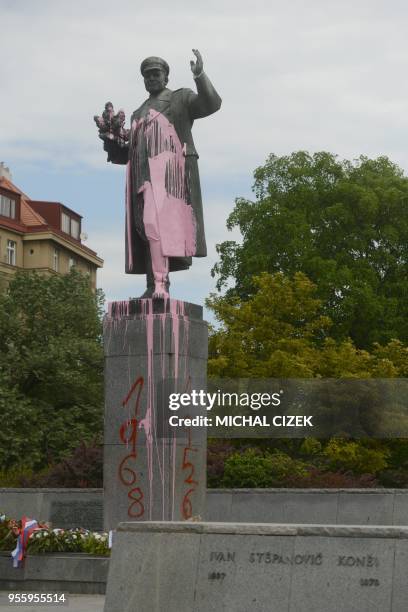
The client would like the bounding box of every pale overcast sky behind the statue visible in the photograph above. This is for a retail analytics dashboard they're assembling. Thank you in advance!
[0,0,408,316]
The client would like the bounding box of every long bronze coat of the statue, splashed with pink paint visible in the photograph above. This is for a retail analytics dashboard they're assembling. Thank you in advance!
[109,73,221,274]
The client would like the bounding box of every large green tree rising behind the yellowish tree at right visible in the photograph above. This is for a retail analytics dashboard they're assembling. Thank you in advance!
[212,151,408,348]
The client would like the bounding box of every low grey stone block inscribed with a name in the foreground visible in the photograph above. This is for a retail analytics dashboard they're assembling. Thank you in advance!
[104,522,408,612]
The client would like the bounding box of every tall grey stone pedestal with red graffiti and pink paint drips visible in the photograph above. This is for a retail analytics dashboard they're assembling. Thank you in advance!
[104,299,208,530]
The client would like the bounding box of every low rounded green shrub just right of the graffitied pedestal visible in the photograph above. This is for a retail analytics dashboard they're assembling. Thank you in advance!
[221,448,307,488]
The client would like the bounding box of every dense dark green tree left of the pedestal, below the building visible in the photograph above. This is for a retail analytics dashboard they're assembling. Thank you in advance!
[0,270,103,469]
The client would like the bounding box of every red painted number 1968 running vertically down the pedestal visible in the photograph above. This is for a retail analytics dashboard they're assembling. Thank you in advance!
[118,376,145,518]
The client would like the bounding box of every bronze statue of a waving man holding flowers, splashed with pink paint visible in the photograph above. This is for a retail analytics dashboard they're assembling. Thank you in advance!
[95,49,221,297]
